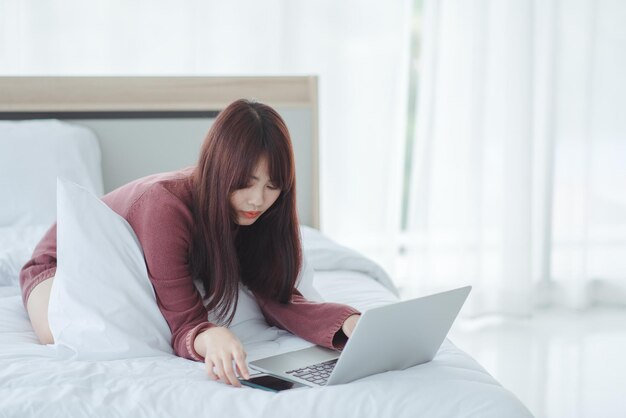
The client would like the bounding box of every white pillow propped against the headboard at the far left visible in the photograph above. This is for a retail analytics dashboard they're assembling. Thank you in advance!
[0,120,103,226]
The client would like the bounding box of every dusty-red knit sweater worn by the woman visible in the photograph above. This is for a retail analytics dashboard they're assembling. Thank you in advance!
[20,169,359,361]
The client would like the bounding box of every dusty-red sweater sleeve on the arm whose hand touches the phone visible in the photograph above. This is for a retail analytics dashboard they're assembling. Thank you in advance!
[128,185,215,361]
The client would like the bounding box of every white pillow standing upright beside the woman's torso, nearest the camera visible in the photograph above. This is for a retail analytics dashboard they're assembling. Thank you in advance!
[48,179,173,360]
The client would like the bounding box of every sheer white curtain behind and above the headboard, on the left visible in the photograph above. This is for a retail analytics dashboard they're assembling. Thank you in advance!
[0,0,410,274]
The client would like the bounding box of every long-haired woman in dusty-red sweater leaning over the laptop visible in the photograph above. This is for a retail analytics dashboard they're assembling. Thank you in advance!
[20,100,360,387]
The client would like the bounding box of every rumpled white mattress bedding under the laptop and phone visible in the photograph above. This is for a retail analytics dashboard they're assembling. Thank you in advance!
[0,270,531,418]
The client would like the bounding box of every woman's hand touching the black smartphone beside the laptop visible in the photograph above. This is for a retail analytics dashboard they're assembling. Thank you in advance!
[194,327,250,387]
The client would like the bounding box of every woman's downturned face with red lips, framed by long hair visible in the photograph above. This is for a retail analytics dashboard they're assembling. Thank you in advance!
[230,157,280,225]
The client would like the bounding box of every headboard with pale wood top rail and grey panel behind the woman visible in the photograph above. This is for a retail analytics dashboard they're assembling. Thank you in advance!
[0,76,319,228]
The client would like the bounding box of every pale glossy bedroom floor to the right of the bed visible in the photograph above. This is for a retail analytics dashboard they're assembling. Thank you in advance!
[449,309,626,418]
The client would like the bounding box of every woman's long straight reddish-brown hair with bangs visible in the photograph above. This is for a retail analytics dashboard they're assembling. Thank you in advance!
[190,99,302,324]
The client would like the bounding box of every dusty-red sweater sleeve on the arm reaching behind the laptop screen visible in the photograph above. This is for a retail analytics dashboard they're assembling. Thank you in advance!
[256,289,361,350]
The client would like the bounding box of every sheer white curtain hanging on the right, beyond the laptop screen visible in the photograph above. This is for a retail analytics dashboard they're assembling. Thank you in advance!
[407,0,626,315]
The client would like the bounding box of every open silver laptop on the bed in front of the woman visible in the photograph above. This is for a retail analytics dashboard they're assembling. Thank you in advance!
[249,286,471,387]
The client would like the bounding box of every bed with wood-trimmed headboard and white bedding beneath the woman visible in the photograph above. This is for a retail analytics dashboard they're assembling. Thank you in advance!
[0,77,531,417]
